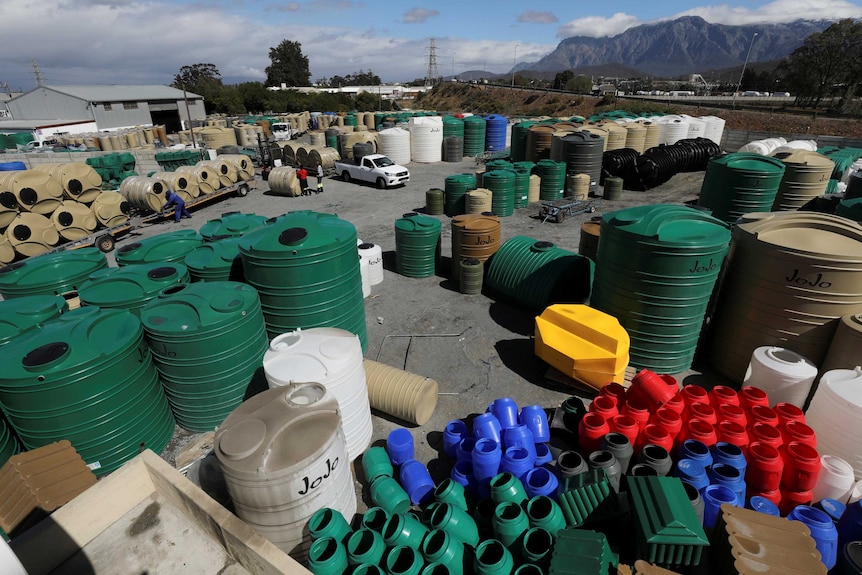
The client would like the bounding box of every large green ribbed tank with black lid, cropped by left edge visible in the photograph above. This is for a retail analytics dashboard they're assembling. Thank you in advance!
[0,306,175,474]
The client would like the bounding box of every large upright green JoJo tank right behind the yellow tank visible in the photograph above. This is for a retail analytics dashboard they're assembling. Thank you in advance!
[590,204,730,374]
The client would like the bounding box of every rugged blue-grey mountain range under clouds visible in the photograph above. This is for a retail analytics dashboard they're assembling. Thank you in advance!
[514,16,833,77]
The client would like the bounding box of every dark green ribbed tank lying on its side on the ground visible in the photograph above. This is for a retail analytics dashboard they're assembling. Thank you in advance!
[484,236,593,313]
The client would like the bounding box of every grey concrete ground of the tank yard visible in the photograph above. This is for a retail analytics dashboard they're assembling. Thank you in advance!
[117,142,736,512]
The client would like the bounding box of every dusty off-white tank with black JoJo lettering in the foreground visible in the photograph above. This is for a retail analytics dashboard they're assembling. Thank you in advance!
[213,383,356,561]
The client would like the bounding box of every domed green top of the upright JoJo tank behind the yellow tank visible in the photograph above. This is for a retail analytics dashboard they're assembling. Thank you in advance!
[602,204,730,247]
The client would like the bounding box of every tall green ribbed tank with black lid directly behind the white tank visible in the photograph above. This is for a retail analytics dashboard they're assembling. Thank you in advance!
[239,210,368,352]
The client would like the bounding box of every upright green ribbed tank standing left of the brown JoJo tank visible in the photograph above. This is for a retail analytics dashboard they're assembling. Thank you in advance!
[395,212,442,278]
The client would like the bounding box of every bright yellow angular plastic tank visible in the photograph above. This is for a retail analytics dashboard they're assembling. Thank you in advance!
[535,304,629,389]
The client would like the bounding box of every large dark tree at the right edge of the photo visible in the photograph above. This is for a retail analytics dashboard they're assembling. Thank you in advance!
[779,18,862,107]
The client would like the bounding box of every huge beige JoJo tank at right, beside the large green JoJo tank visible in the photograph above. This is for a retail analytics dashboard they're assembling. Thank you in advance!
[712,211,862,382]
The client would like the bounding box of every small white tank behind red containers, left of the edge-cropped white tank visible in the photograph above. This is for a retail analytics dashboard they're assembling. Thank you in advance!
[743,345,817,408]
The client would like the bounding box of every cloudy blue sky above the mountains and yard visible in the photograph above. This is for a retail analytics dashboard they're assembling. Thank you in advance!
[0,0,862,91]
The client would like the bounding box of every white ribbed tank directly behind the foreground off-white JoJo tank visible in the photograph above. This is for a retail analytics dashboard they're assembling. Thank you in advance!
[263,327,372,461]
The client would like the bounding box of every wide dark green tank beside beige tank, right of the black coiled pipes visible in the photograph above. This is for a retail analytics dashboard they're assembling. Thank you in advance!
[697,152,784,223]
